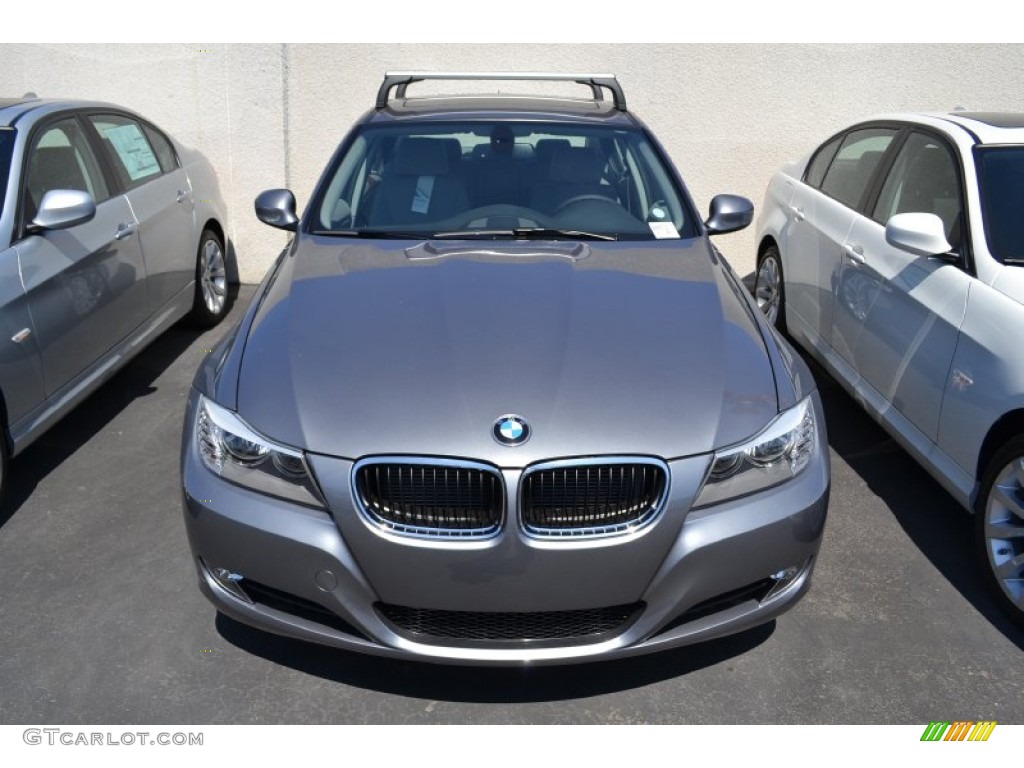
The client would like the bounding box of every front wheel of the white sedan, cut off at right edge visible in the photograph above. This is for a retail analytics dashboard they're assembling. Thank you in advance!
[975,435,1024,628]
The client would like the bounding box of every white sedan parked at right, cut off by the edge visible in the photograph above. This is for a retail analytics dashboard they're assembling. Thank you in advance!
[755,112,1024,625]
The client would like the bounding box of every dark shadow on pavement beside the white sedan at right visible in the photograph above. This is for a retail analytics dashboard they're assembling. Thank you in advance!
[801,350,1024,650]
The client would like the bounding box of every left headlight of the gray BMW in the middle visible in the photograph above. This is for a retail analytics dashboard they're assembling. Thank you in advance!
[196,395,324,507]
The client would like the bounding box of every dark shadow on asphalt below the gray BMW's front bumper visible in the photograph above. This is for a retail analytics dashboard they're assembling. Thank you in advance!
[217,613,775,703]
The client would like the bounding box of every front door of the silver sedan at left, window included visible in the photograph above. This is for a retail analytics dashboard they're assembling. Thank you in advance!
[14,117,146,396]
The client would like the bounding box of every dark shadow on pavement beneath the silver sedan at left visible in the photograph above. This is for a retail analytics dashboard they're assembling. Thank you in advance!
[0,315,222,527]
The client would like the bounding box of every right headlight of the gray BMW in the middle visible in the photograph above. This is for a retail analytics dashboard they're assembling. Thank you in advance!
[693,397,816,509]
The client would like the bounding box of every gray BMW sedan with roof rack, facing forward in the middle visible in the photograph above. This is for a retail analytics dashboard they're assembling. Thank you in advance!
[181,73,829,665]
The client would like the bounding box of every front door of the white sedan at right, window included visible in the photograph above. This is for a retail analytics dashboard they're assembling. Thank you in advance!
[836,131,972,440]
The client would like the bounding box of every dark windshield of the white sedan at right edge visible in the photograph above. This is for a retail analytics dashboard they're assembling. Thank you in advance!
[977,146,1024,262]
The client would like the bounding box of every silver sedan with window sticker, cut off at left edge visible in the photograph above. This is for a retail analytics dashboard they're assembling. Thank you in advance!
[0,97,227,501]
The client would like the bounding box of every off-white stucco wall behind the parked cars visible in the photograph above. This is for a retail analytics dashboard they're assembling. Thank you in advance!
[0,43,1024,282]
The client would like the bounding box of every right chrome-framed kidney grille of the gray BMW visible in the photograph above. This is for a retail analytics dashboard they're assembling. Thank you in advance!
[519,456,670,540]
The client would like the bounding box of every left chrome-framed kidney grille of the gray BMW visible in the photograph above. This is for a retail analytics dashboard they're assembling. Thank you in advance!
[352,456,505,541]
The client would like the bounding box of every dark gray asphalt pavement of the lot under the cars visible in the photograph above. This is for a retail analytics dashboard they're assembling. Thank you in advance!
[0,287,1024,726]
